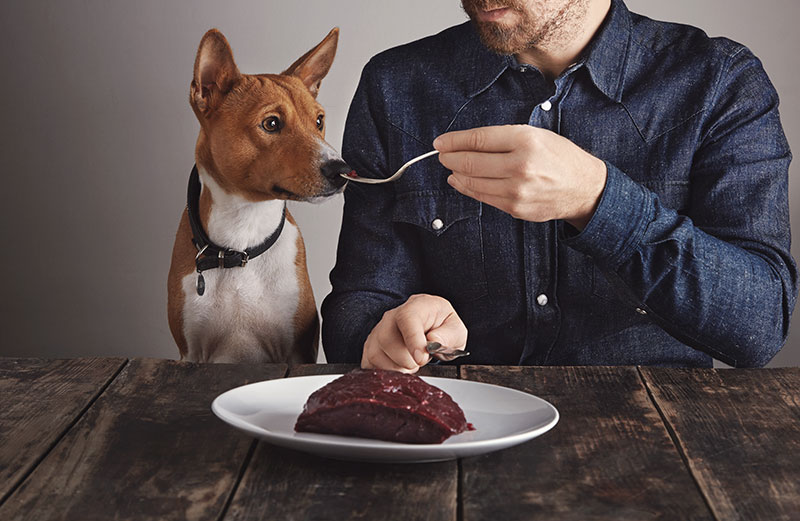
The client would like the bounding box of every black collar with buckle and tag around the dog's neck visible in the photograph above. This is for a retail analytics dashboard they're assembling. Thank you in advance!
[186,165,286,274]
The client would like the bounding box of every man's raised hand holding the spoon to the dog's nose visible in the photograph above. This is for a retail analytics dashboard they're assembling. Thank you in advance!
[433,125,607,230]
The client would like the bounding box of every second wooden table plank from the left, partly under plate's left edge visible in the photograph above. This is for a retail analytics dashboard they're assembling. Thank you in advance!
[0,359,286,520]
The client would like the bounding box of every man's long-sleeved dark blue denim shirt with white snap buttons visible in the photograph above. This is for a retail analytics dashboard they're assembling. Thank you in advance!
[322,0,797,367]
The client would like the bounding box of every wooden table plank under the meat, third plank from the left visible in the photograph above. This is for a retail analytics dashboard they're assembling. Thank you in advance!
[225,365,458,521]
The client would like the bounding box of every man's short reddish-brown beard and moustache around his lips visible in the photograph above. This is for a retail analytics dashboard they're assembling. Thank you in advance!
[461,0,586,55]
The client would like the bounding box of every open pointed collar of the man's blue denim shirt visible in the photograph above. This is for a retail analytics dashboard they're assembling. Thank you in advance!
[464,0,631,102]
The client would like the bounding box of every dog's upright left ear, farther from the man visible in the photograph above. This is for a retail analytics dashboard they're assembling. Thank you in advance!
[189,29,242,114]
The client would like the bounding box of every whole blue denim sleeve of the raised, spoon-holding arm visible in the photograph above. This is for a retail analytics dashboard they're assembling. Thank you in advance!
[561,48,797,367]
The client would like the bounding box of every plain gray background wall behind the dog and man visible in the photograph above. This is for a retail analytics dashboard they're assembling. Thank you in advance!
[0,0,800,366]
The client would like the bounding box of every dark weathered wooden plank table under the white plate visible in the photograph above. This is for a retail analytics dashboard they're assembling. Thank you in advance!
[0,358,800,521]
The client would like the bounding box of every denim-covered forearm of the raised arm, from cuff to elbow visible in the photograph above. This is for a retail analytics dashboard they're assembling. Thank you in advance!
[566,167,796,366]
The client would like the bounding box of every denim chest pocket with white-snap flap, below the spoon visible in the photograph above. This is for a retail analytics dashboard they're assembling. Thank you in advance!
[393,191,488,302]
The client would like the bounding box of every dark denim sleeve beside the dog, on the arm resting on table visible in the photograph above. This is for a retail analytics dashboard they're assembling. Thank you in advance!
[321,64,422,363]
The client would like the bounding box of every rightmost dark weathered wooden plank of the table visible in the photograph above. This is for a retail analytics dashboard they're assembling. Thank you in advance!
[641,367,800,521]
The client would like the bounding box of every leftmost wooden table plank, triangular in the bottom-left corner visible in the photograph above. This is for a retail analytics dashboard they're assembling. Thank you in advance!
[0,358,126,504]
